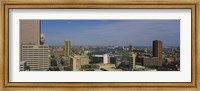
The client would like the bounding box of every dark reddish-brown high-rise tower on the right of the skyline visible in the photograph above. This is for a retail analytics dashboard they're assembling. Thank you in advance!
[153,40,162,65]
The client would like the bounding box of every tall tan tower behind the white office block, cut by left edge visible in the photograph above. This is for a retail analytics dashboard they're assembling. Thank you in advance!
[20,20,40,61]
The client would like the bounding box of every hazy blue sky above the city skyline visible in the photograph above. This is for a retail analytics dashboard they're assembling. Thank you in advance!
[41,20,180,46]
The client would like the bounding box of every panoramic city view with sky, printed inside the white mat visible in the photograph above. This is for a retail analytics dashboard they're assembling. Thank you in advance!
[19,20,180,71]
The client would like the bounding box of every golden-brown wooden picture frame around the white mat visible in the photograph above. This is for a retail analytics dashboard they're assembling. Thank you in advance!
[0,1,200,91]
